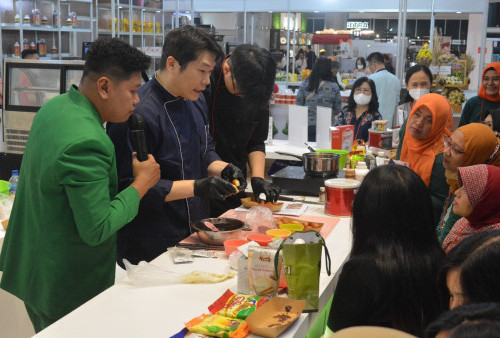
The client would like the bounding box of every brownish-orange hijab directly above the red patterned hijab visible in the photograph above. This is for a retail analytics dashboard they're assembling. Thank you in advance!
[446,123,500,193]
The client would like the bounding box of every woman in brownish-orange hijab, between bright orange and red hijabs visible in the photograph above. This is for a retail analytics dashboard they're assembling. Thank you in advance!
[437,123,500,242]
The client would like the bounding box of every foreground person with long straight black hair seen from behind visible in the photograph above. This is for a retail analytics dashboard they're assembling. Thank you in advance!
[327,164,446,336]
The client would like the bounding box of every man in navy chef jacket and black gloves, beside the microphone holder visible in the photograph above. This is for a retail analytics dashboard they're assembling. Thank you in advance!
[108,25,246,266]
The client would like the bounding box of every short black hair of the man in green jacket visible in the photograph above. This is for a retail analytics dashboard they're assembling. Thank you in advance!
[82,38,151,82]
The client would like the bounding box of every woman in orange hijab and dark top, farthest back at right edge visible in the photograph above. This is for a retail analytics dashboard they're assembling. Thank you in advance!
[458,62,500,126]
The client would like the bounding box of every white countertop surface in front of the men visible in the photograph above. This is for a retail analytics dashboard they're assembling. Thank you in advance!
[36,205,352,338]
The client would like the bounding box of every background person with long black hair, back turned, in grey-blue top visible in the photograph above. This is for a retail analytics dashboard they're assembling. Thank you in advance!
[297,58,341,141]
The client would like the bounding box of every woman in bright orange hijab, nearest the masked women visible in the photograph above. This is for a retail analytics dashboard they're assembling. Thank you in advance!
[400,93,452,223]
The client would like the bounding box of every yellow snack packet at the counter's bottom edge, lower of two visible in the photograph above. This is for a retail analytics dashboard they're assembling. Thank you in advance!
[185,314,250,338]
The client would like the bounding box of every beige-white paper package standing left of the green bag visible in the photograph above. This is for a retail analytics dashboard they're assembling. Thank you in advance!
[248,246,281,297]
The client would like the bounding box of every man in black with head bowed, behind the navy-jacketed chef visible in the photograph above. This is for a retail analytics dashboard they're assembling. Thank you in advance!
[206,44,280,217]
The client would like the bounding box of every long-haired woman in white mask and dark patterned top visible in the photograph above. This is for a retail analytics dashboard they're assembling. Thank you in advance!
[333,77,382,141]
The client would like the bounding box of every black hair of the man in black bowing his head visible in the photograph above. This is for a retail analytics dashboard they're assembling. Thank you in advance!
[228,44,276,107]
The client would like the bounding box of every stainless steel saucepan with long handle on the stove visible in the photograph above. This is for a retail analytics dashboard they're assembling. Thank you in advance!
[276,151,340,177]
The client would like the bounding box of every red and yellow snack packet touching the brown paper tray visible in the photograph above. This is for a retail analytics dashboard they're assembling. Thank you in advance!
[208,290,267,319]
